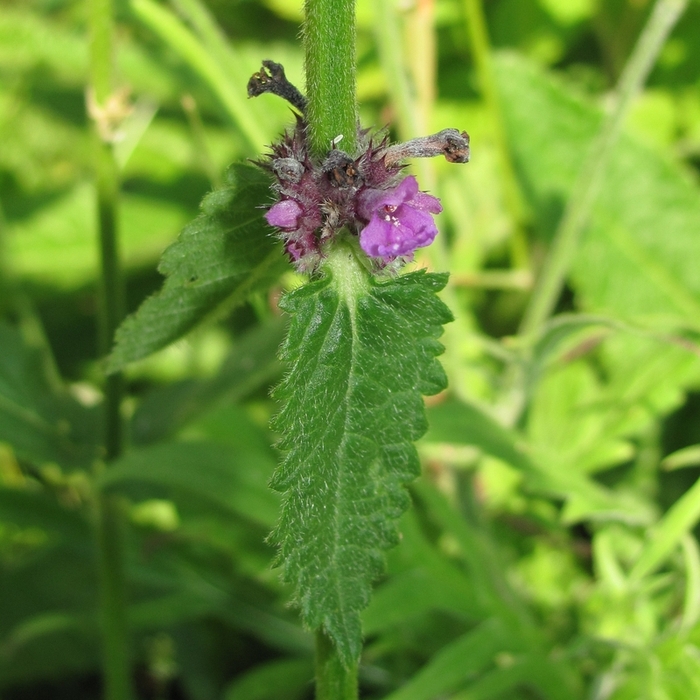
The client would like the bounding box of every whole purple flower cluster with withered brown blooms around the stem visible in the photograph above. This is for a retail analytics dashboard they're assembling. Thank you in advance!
[248,61,469,272]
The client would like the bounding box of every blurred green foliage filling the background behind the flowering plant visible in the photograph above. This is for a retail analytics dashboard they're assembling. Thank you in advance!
[0,0,700,700]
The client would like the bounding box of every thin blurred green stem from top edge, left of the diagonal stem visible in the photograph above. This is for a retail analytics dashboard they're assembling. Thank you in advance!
[464,0,528,268]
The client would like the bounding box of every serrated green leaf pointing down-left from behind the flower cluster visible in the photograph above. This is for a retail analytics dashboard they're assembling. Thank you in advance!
[108,164,286,372]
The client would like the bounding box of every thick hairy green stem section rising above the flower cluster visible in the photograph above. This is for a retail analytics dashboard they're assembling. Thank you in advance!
[304,0,357,158]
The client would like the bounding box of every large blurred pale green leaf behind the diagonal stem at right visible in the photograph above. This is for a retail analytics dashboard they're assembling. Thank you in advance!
[497,54,700,328]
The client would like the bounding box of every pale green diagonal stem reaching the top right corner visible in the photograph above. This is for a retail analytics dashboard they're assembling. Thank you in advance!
[521,0,688,334]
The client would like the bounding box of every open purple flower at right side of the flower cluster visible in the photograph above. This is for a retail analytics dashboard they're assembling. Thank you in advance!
[357,175,442,262]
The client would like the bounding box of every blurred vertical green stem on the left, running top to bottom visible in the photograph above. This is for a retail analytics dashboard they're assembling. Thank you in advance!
[88,0,132,700]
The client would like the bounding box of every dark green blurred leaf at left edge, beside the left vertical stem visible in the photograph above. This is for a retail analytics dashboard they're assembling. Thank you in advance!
[0,324,99,468]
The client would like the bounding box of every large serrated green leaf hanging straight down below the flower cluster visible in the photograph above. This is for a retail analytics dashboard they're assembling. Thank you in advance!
[272,243,452,665]
